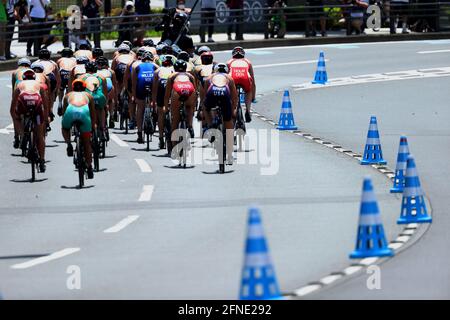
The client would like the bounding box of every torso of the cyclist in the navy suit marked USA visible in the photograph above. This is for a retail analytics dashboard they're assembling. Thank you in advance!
[204,73,231,121]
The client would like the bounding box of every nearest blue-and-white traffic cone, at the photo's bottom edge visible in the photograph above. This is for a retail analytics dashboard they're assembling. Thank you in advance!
[239,207,281,300]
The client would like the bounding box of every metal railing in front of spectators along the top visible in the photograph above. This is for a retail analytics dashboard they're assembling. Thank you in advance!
[0,2,450,41]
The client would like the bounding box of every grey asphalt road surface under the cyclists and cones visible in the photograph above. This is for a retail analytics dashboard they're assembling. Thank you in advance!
[0,41,450,299]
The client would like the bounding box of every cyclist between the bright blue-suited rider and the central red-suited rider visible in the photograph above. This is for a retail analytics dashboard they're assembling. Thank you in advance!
[152,57,175,149]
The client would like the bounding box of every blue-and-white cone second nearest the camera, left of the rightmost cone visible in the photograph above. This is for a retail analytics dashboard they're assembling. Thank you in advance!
[350,177,394,259]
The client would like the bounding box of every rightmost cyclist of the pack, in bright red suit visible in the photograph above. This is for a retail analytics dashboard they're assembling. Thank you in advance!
[227,47,256,122]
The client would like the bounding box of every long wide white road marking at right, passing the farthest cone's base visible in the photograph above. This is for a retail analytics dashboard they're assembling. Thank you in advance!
[292,67,450,91]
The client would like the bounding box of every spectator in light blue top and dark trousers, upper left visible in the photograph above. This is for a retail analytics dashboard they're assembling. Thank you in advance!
[27,0,50,57]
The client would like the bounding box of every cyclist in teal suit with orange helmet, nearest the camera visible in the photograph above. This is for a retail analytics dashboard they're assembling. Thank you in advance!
[61,79,97,179]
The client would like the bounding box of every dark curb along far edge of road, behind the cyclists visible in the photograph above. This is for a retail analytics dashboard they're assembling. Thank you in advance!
[0,32,450,72]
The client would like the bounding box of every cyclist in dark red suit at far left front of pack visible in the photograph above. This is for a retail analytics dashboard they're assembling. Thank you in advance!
[10,69,47,172]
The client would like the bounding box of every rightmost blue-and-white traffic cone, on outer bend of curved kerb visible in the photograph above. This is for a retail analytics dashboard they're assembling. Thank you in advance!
[397,155,432,224]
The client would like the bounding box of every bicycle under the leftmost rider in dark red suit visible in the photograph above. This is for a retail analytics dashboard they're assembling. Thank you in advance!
[22,108,40,182]
